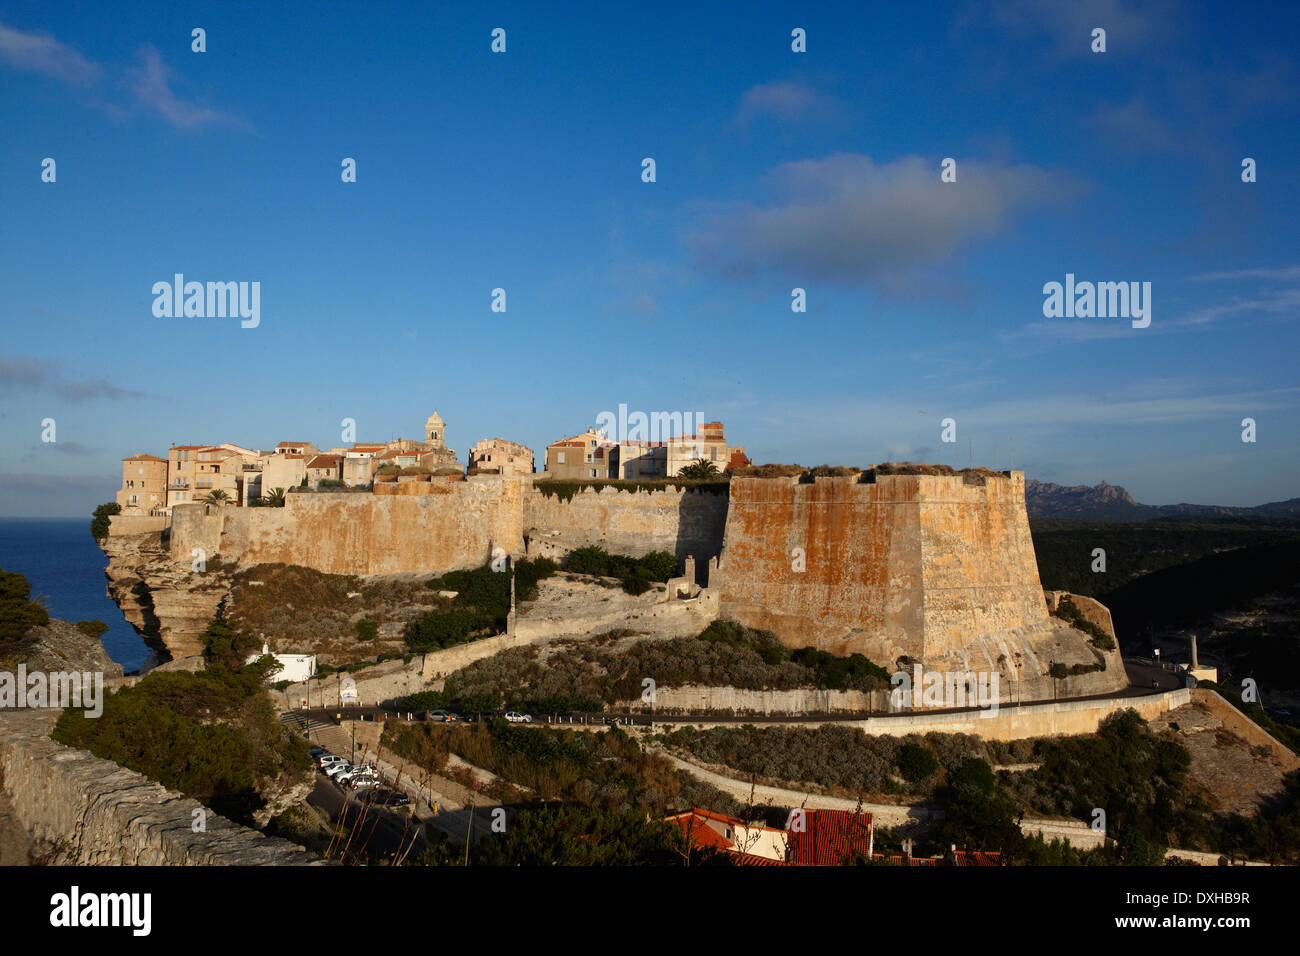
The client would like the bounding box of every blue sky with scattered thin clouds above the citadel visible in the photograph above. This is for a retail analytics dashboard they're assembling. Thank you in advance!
[0,0,1300,515]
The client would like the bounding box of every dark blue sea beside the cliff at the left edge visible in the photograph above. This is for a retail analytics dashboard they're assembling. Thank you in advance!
[0,518,150,672]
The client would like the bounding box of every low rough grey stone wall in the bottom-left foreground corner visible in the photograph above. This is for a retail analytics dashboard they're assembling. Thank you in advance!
[0,710,321,866]
